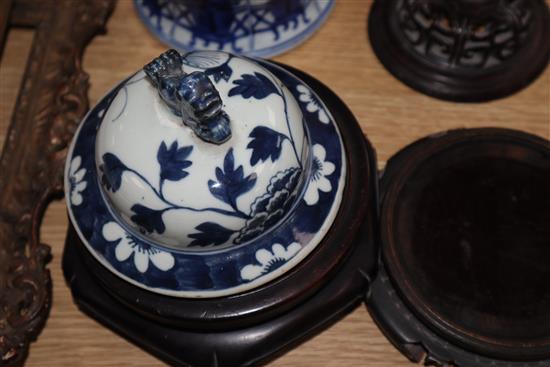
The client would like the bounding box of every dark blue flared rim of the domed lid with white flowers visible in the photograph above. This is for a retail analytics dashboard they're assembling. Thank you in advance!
[66,62,345,297]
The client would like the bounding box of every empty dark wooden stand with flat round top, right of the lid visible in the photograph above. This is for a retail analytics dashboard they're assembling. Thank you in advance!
[367,128,550,367]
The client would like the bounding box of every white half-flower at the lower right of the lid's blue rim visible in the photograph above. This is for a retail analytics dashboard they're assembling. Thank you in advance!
[241,242,302,280]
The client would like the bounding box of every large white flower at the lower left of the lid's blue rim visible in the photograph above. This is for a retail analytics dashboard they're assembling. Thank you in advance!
[102,222,174,273]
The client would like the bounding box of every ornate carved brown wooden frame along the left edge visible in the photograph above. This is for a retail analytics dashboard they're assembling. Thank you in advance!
[0,0,115,365]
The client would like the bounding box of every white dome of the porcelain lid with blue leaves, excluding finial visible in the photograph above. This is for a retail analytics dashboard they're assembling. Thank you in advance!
[95,52,314,250]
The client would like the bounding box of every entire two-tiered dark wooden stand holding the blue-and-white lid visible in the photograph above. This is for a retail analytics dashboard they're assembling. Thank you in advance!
[63,67,378,366]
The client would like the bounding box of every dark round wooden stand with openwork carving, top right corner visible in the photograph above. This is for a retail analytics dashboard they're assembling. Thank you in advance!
[368,0,550,102]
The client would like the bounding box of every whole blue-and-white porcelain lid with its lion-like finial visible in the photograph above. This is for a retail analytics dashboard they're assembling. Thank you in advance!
[65,51,345,297]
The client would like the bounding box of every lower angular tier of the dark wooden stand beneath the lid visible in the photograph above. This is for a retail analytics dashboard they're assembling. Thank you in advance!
[63,218,376,366]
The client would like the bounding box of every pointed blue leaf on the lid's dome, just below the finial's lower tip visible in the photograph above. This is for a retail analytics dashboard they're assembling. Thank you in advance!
[208,148,256,211]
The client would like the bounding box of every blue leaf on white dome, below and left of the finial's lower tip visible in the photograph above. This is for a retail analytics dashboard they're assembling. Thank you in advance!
[157,141,193,181]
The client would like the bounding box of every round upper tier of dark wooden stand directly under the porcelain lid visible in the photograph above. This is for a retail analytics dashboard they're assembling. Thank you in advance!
[63,61,376,329]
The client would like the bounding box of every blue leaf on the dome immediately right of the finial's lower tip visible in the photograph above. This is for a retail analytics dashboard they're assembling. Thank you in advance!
[246,126,288,166]
